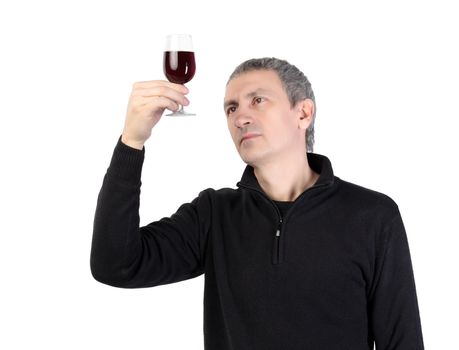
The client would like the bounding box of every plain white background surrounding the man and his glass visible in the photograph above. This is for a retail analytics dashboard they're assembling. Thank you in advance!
[0,0,459,350]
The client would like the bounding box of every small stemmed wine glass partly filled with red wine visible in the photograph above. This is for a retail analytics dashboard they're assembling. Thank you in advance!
[163,34,196,116]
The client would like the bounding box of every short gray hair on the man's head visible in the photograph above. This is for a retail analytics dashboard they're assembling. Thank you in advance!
[227,57,316,152]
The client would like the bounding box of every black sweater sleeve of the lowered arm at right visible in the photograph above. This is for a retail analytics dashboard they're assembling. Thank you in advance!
[368,210,424,350]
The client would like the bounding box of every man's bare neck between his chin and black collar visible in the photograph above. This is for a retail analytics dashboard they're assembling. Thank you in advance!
[254,154,319,202]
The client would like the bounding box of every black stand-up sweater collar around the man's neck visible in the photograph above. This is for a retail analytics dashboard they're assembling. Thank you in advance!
[237,152,334,191]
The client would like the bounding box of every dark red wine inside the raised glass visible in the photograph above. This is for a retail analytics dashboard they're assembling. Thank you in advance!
[164,51,196,84]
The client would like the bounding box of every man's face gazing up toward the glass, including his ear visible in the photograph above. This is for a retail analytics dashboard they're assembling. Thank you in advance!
[224,70,313,166]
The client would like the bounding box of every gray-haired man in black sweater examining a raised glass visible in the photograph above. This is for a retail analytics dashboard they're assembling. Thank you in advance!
[91,58,424,350]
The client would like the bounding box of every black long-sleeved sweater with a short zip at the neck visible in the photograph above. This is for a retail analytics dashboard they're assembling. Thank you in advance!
[91,138,424,350]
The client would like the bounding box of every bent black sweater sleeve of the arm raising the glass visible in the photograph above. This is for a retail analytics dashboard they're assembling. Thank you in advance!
[90,137,208,288]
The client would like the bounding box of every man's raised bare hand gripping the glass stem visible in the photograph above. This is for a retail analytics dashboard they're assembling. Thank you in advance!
[121,80,189,150]
